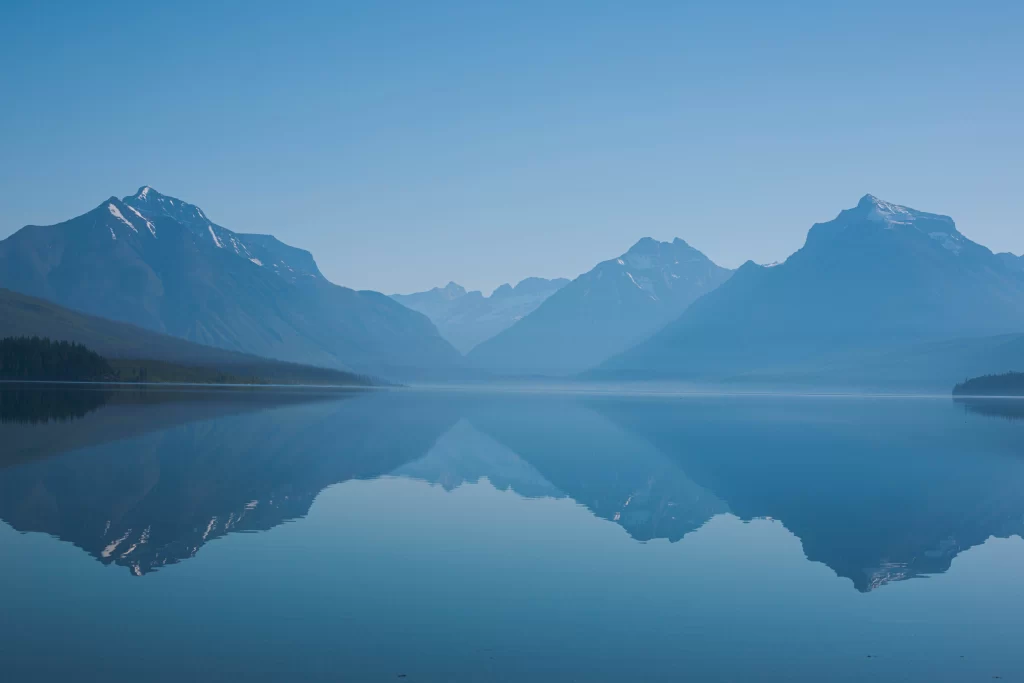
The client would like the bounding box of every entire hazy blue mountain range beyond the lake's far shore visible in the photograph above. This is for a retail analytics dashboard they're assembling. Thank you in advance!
[0,186,1024,388]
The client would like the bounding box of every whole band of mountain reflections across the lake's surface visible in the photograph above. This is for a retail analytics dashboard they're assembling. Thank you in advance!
[0,391,1024,591]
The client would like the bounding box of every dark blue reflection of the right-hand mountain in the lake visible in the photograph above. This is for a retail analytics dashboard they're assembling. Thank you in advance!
[594,397,1024,591]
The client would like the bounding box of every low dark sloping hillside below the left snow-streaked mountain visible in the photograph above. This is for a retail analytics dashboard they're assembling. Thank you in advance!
[0,289,366,384]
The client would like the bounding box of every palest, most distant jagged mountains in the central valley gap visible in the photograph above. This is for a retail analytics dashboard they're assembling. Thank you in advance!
[391,278,569,353]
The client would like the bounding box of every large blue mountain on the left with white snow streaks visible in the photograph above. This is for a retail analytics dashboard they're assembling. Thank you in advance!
[0,187,459,376]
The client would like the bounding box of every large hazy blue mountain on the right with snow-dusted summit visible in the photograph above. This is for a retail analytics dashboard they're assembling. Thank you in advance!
[595,195,1024,379]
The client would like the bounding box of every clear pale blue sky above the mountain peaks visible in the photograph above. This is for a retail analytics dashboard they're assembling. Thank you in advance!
[0,0,1024,293]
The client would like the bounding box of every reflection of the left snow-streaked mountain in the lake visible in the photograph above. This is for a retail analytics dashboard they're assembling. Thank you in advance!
[0,393,457,575]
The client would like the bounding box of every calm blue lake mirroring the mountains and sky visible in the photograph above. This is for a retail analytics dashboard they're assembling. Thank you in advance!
[0,385,1024,683]
